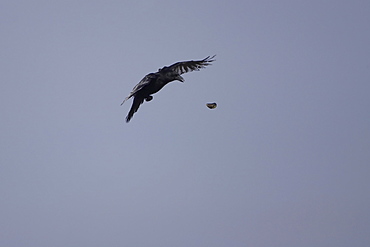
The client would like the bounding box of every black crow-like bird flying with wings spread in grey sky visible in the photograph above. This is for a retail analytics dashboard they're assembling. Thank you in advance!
[121,56,215,123]
